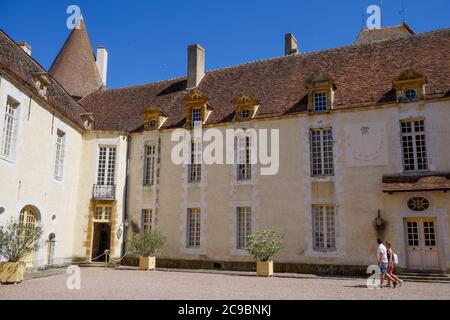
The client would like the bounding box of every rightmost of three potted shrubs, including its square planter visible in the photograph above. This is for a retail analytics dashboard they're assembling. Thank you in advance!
[246,230,283,277]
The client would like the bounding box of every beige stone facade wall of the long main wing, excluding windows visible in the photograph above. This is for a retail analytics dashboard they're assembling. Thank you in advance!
[125,102,450,269]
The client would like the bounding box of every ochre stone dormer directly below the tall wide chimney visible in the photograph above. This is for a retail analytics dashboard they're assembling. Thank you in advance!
[184,89,213,128]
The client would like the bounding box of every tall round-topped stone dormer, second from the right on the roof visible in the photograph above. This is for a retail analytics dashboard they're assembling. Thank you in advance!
[306,72,336,113]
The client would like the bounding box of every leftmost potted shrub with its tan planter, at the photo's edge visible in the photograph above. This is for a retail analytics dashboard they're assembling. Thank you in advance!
[0,221,42,283]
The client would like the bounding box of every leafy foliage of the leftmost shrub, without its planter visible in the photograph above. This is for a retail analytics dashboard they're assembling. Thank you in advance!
[0,221,43,262]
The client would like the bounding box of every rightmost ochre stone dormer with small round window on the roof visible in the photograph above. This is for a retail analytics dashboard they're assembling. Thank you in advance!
[393,69,427,102]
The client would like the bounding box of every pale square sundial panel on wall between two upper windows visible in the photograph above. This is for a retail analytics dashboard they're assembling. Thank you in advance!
[345,122,388,167]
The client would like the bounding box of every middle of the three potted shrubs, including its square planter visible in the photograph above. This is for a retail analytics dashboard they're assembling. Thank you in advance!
[130,231,166,270]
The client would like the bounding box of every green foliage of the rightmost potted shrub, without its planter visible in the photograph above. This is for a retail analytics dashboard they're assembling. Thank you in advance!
[245,230,284,262]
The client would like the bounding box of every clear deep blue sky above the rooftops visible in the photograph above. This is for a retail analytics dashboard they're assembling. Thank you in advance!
[0,0,450,88]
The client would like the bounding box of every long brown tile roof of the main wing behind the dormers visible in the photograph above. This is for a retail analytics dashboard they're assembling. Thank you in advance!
[81,29,450,131]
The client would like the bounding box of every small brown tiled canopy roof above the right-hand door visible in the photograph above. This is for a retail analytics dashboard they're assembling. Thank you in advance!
[383,173,450,193]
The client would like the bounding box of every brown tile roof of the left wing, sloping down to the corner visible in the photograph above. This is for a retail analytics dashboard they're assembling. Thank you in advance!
[0,30,86,128]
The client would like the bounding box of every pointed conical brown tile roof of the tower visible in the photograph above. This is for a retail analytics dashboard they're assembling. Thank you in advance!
[49,18,103,98]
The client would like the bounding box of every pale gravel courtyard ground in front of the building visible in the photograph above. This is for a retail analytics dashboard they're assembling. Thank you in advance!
[0,268,450,300]
